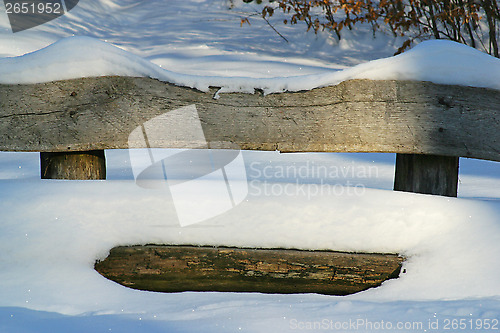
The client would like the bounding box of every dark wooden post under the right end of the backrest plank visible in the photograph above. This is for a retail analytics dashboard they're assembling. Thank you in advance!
[394,154,458,197]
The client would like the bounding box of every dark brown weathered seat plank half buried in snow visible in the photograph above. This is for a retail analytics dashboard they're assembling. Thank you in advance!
[95,245,403,295]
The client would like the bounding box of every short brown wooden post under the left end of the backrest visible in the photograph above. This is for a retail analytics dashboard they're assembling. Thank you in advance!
[40,150,106,180]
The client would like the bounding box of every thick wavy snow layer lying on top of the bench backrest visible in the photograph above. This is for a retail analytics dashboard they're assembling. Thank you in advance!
[0,37,500,93]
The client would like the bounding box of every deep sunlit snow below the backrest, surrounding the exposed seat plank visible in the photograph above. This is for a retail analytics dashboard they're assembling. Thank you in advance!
[0,151,500,332]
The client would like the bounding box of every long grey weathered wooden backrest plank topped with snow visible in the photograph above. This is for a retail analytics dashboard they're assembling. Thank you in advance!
[0,77,500,161]
